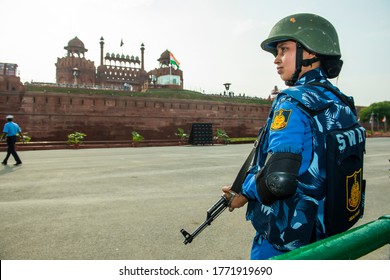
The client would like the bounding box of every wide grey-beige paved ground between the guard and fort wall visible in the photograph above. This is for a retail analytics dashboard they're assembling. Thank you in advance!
[0,138,390,260]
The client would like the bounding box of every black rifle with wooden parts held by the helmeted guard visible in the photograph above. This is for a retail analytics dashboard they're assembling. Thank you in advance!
[180,130,263,245]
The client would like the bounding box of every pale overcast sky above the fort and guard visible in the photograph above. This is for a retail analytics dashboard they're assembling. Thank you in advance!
[0,0,390,106]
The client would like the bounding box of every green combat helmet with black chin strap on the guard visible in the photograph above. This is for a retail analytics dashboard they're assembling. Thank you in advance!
[261,14,342,82]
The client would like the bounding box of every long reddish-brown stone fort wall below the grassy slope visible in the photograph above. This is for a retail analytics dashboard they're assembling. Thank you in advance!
[0,92,270,141]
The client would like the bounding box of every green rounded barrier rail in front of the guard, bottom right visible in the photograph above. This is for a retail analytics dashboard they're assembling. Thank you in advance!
[270,215,390,260]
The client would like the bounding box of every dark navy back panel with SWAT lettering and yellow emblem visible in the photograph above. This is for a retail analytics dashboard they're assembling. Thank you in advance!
[325,124,366,236]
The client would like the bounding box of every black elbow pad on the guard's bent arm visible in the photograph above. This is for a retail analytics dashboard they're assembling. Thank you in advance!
[256,153,302,205]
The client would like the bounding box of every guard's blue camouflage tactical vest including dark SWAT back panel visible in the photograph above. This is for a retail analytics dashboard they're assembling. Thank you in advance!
[282,83,366,236]
